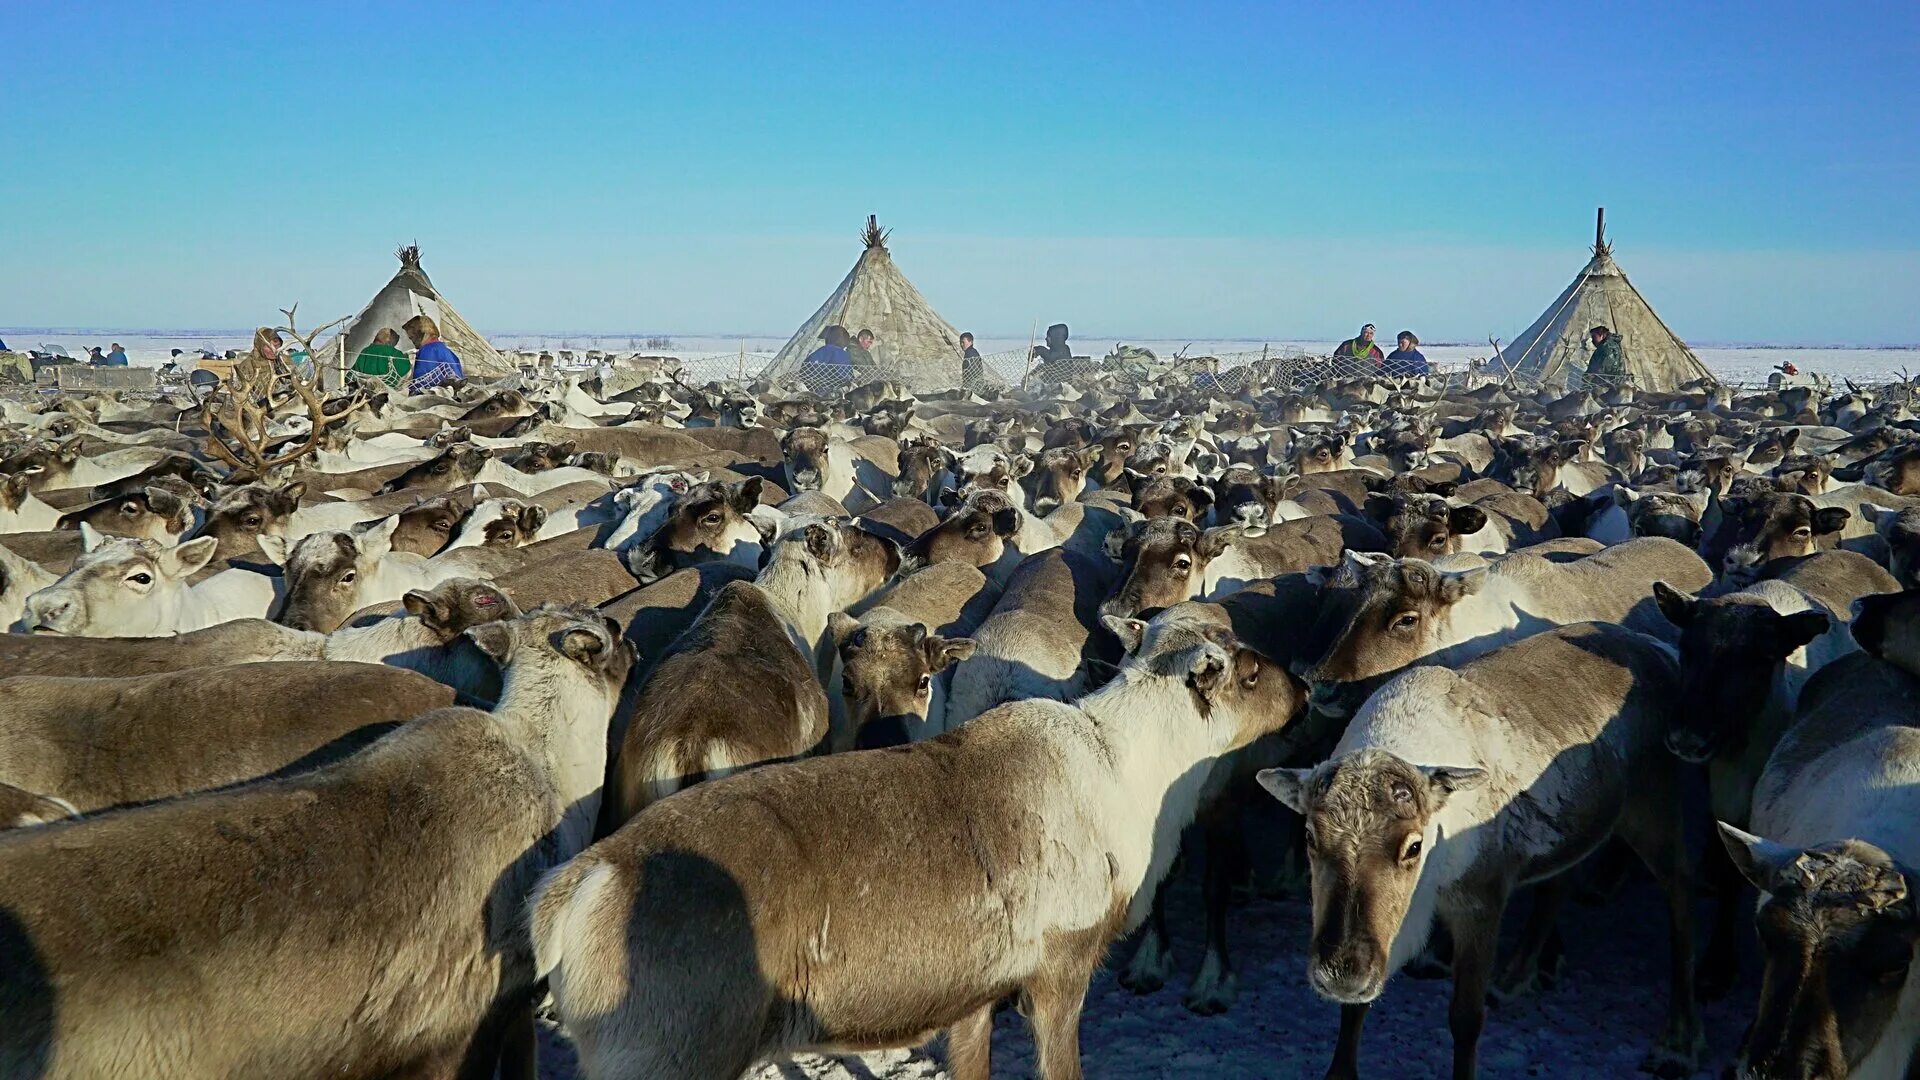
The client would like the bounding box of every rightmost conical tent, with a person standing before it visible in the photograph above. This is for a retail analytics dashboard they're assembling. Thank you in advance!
[1501,209,1715,392]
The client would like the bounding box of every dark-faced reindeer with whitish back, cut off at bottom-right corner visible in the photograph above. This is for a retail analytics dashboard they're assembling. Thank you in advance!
[1720,592,1920,1080]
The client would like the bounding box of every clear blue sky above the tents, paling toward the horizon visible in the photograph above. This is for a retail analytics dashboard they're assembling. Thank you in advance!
[0,0,1920,342]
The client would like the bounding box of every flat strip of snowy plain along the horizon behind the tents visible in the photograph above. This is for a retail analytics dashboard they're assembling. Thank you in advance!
[0,327,1920,384]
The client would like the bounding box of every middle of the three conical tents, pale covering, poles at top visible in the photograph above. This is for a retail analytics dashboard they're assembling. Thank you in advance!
[766,215,960,390]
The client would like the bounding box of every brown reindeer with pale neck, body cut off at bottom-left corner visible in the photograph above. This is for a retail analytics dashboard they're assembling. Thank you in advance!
[0,607,632,1080]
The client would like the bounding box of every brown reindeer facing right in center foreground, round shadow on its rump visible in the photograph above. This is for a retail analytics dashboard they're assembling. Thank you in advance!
[532,605,1288,1080]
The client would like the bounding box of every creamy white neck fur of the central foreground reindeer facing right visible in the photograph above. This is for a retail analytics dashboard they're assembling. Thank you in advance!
[1075,669,1221,930]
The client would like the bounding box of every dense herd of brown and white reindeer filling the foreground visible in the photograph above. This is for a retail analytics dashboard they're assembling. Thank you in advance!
[0,363,1920,1080]
